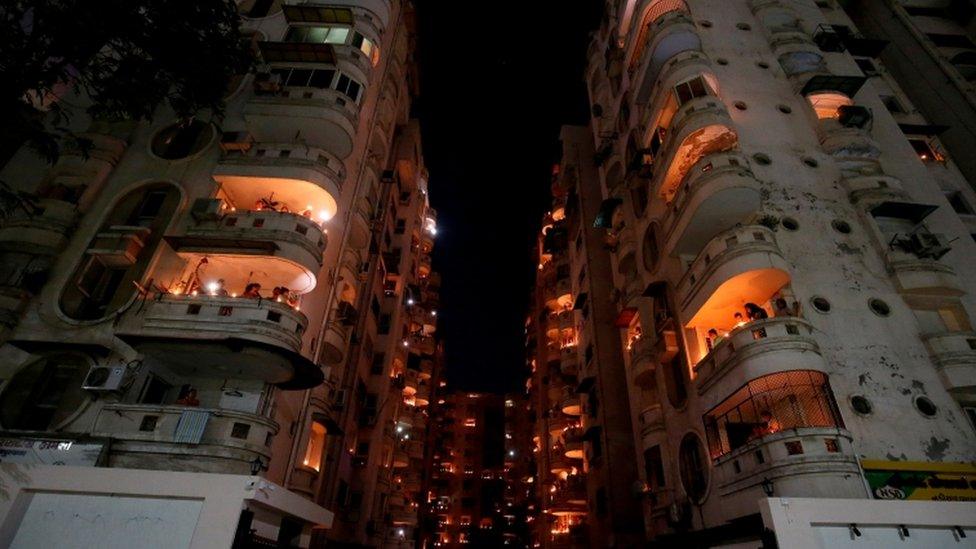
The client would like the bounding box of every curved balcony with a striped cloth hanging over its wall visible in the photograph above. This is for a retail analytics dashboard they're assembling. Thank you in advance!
[91,403,278,475]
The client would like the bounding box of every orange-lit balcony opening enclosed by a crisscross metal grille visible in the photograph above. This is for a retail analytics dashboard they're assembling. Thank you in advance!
[702,370,844,459]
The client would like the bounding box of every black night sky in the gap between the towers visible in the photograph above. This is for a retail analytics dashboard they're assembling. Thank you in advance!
[414,0,603,392]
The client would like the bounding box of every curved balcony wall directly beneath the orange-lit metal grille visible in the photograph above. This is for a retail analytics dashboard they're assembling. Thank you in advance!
[713,427,869,519]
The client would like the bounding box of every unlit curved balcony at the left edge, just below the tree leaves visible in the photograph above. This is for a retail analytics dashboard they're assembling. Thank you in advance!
[0,198,78,255]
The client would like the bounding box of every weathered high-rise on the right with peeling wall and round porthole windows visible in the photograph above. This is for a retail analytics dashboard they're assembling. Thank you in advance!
[527,0,976,547]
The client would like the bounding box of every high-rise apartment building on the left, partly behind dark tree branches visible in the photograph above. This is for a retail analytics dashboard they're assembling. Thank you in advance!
[0,0,441,547]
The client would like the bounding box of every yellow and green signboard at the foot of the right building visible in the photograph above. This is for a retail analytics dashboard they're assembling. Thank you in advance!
[861,460,976,501]
